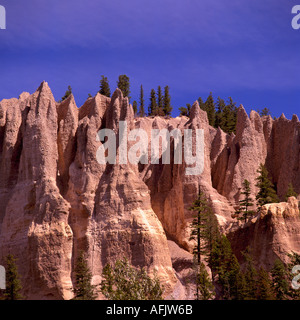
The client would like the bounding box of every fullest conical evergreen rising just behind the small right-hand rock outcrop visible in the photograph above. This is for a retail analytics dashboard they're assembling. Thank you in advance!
[256,164,279,207]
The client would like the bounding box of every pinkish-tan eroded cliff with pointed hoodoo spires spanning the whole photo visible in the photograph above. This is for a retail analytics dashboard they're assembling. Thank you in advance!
[0,82,300,299]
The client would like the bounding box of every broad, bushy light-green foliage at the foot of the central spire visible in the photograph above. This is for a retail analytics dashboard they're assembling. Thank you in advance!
[101,258,163,300]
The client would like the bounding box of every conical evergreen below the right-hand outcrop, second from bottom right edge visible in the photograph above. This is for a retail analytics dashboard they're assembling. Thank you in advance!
[271,259,289,300]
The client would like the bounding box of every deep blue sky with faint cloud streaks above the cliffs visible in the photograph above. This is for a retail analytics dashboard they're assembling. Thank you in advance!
[0,0,300,118]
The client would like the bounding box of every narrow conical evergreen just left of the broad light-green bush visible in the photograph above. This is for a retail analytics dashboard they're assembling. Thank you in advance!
[73,251,96,300]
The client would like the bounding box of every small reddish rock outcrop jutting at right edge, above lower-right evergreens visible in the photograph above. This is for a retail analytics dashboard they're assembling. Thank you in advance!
[229,197,300,270]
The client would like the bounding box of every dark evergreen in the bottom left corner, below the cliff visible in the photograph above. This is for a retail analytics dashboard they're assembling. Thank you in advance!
[4,254,23,300]
